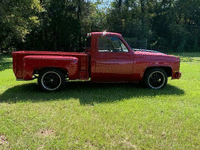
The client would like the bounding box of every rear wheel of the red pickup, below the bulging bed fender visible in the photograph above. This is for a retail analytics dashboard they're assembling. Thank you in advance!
[38,69,65,92]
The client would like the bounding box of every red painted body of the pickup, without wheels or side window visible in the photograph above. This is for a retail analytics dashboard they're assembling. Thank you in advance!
[12,32,181,82]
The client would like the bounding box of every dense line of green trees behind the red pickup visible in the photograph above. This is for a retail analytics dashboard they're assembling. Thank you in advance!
[0,0,200,52]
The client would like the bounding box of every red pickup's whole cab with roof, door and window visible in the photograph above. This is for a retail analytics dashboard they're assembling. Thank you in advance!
[86,32,134,82]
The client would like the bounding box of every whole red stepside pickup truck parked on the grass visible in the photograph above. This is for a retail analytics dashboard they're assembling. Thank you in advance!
[12,32,181,91]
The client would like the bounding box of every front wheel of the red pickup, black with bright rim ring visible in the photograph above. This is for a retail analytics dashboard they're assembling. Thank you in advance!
[144,68,168,90]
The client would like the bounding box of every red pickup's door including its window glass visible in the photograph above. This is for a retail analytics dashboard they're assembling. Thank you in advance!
[93,36,133,82]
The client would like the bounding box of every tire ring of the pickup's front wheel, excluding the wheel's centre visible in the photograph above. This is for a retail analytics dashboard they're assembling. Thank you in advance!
[144,68,168,90]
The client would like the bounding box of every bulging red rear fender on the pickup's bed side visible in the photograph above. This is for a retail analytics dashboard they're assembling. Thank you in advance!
[23,55,79,80]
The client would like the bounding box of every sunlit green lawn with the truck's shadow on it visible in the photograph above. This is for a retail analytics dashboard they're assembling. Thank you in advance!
[0,53,200,150]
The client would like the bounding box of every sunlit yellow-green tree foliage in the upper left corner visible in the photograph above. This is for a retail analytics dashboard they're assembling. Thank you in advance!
[0,0,43,48]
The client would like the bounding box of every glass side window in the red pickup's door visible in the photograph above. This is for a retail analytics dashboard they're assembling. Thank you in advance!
[98,36,128,53]
